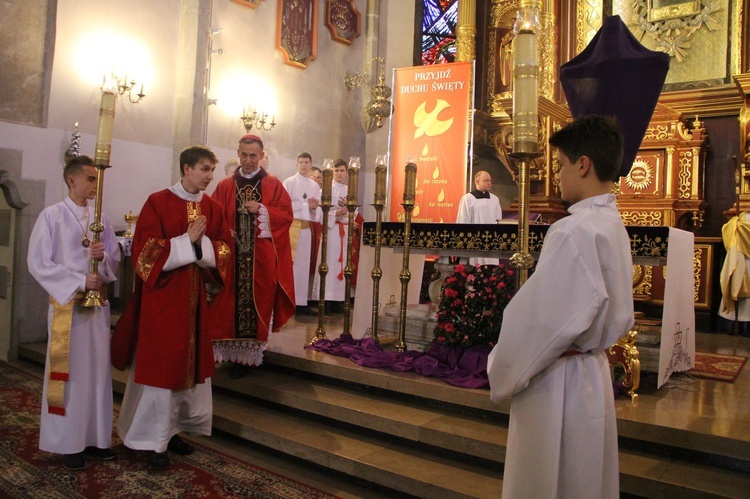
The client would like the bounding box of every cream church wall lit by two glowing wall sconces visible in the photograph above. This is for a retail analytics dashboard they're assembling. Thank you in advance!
[0,0,374,233]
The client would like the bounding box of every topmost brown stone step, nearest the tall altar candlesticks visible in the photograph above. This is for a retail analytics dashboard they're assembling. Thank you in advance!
[265,351,750,471]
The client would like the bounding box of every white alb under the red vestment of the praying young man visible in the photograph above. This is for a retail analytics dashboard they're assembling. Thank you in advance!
[117,182,216,452]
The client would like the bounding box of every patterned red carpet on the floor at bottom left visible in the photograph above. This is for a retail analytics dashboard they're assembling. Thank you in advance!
[0,362,334,499]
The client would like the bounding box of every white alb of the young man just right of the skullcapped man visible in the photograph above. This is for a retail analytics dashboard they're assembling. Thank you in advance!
[283,173,321,307]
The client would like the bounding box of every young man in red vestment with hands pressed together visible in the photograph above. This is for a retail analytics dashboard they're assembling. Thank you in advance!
[112,146,231,468]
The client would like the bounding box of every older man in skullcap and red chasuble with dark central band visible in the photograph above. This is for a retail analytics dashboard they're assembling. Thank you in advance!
[213,135,295,375]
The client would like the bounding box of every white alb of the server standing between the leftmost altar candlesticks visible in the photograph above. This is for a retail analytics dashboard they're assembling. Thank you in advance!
[312,182,357,301]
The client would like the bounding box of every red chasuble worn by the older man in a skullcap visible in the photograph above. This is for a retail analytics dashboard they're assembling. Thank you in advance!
[213,171,295,343]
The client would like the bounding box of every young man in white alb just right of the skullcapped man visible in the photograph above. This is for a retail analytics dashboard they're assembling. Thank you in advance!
[284,152,322,317]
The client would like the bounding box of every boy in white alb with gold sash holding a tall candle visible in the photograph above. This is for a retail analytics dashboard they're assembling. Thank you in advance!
[27,156,120,470]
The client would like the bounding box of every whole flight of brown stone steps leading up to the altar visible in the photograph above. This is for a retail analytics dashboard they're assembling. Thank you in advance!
[20,344,750,497]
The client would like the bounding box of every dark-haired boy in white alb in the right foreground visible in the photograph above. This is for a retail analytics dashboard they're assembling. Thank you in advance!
[487,116,633,499]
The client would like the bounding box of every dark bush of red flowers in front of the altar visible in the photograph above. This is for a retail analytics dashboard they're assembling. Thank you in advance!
[433,264,516,348]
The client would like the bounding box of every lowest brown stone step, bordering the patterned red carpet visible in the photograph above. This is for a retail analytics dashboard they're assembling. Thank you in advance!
[213,393,502,498]
